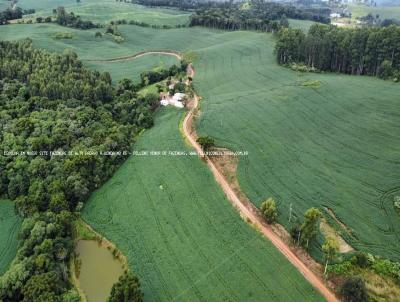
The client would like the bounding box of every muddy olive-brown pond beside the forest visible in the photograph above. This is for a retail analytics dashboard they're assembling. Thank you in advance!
[76,240,123,302]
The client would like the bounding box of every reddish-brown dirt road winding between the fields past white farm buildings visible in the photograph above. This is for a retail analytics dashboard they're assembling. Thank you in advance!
[96,51,340,302]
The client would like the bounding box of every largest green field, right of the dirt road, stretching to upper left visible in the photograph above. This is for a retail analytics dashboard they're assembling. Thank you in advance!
[0,20,400,260]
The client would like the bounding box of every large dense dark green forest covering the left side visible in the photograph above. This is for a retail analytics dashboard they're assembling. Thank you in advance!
[0,40,150,302]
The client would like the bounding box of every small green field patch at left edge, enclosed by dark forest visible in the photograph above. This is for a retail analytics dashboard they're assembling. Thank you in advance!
[0,200,21,276]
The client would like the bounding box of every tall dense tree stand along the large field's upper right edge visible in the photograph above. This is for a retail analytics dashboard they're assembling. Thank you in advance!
[276,24,400,78]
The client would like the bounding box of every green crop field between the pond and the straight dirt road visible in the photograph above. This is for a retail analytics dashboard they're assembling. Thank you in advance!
[83,109,322,301]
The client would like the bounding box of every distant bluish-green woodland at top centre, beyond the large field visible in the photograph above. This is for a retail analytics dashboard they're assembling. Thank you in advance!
[190,0,330,32]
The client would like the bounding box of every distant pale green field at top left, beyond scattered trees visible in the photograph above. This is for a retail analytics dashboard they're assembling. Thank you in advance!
[6,0,190,26]
